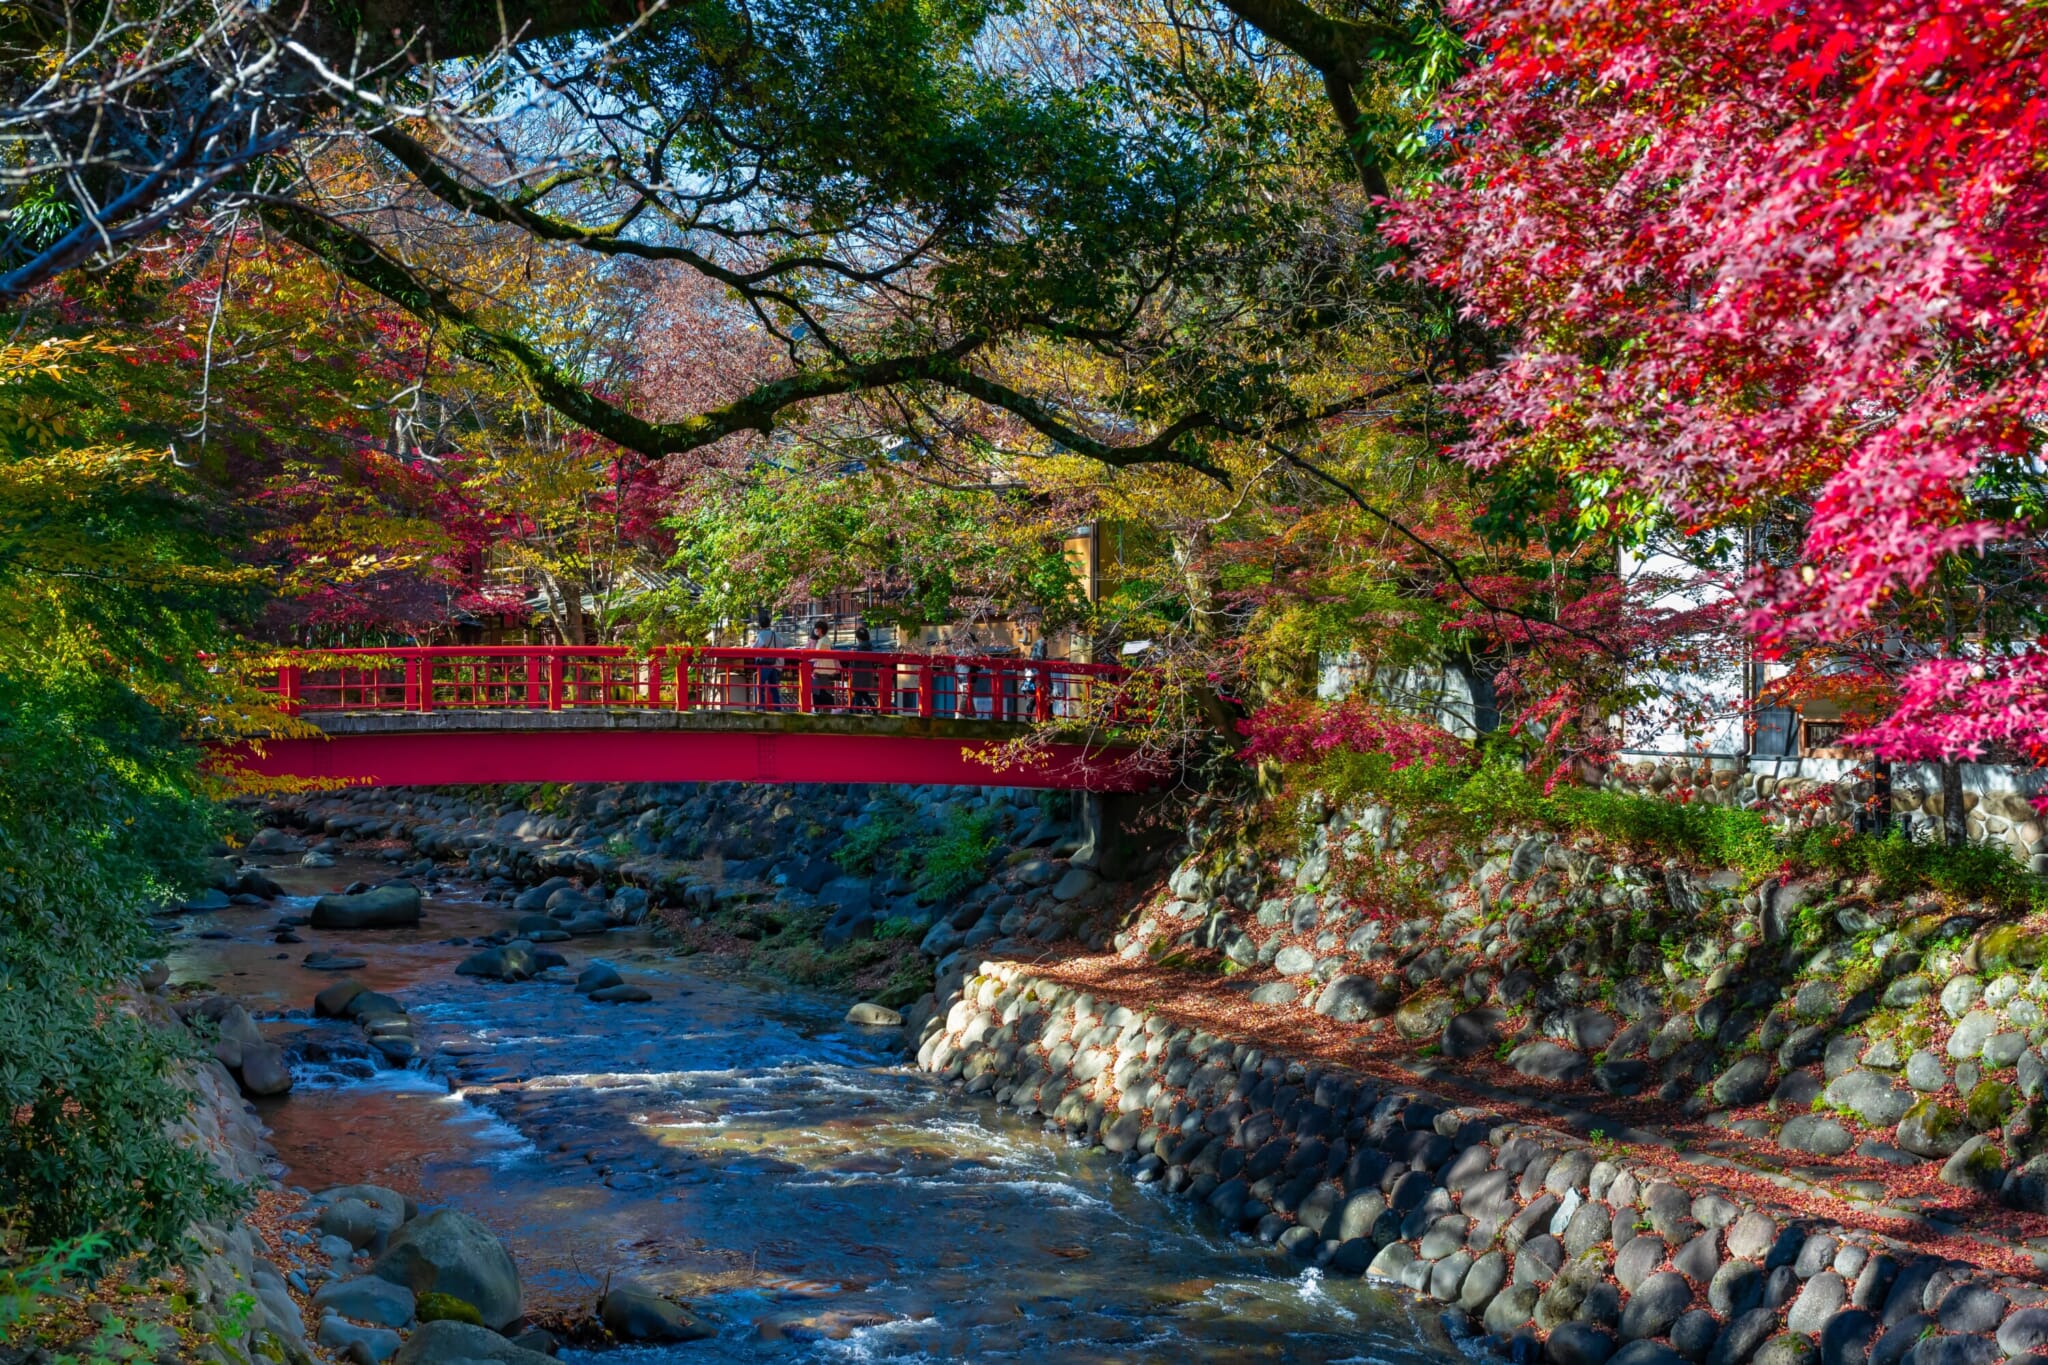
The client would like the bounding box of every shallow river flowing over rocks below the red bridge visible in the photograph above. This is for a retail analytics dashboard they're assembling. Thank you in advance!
[172,862,1458,1365]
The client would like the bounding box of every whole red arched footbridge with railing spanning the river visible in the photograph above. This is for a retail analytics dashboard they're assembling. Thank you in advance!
[244,645,1161,792]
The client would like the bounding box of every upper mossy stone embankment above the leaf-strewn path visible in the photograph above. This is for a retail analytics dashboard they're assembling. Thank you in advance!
[1116,806,2048,1219]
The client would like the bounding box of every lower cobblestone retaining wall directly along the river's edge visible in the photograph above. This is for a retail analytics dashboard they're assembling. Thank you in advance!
[918,962,2048,1365]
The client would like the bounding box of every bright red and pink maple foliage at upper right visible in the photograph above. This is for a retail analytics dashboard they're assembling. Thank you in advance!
[1393,0,2048,757]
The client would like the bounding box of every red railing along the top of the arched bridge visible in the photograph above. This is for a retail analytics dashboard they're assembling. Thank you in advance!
[272,645,1126,724]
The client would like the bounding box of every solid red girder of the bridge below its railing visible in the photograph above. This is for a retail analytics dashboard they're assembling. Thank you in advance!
[244,710,1159,792]
